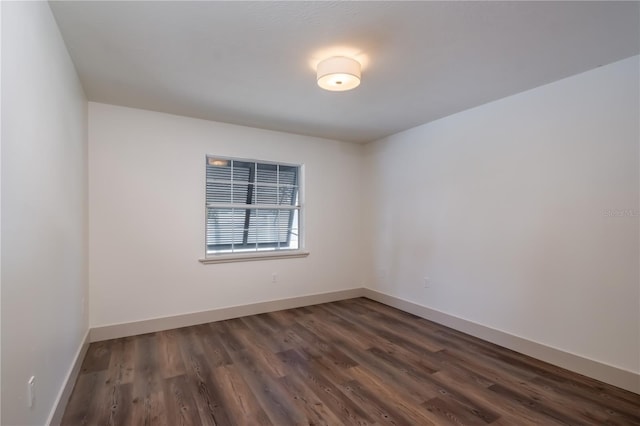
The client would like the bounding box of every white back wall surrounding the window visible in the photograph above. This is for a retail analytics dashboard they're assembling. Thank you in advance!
[89,103,364,327]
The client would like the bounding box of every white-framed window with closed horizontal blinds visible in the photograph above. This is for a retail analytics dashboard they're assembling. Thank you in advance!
[206,156,300,255]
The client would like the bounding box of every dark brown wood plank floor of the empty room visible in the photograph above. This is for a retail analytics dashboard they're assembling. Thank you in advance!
[62,298,640,426]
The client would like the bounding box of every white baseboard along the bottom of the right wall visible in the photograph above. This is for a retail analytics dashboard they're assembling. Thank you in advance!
[363,288,640,394]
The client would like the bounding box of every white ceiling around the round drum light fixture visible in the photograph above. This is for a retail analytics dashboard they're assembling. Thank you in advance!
[50,1,640,142]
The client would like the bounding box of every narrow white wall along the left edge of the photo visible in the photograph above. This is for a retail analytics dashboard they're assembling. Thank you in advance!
[0,2,88,425]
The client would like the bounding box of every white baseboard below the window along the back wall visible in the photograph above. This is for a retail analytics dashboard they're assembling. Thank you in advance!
[90,288,364,342]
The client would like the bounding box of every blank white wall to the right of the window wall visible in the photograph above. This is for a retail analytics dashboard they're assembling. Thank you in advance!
[366,57,640,373]
